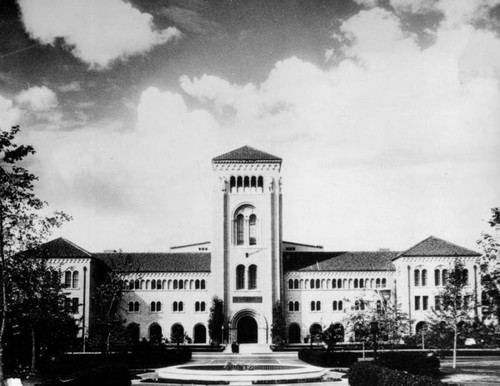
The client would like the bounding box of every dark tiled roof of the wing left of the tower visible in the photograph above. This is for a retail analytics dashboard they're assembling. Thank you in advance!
[94,252,210,272]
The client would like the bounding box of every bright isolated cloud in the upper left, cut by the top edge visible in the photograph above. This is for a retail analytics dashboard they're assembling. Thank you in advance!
[18,0,180,68]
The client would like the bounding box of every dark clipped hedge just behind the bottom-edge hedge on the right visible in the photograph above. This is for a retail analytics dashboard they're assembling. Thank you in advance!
[376,351,440,378]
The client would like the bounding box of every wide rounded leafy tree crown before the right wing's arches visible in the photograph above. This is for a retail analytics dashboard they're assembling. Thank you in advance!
[345,295,410,346]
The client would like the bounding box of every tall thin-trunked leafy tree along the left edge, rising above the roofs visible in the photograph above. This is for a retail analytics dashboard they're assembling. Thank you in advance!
[0,126,69,384]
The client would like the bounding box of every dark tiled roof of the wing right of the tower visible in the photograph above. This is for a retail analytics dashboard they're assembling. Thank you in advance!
[283,251,398,271]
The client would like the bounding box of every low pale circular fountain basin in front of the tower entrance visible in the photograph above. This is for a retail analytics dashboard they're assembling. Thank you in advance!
[133,361,327,386]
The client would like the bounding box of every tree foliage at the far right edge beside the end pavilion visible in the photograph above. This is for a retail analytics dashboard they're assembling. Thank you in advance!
[477,208,500,323]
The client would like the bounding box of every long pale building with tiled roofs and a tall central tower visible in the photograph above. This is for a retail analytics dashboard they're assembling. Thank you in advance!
[35,146,481,344]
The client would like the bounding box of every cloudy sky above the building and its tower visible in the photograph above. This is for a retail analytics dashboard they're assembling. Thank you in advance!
[0,0,500,252]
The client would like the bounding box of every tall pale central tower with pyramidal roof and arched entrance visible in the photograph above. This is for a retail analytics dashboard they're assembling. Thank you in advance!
[211,146,282,343]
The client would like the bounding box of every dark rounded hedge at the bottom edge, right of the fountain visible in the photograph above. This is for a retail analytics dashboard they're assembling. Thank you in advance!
[348,362,445,386]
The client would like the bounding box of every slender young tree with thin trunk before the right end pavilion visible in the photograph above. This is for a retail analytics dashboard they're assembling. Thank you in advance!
[430,259,473,368]
